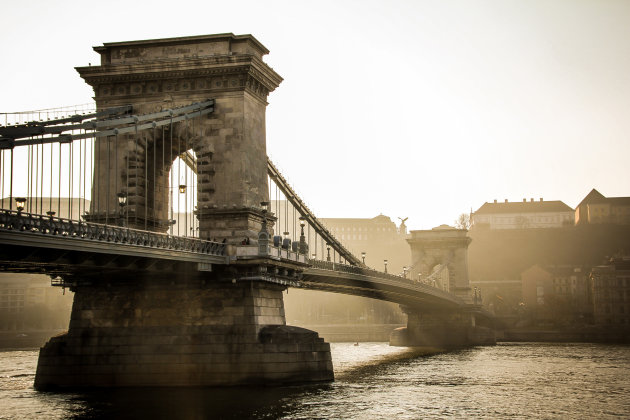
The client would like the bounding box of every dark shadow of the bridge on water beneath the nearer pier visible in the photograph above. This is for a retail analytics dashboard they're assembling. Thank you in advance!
[51,348,452,420]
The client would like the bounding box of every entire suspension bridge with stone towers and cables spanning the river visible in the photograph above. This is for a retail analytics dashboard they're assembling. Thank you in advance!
[0,34,493,389]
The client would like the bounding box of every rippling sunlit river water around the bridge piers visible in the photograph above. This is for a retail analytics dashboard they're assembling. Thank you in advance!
[0,343,630,420]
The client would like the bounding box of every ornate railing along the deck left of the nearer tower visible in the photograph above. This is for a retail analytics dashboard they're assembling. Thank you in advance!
[0,210,226,256]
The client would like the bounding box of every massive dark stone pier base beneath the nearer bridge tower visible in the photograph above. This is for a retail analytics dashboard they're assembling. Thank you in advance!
[35,280,333,390]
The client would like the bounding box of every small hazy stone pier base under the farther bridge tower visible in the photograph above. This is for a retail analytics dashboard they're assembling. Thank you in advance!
[389,307,496,349]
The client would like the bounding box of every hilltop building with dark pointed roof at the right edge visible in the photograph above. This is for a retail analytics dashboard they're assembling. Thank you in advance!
[575,188,630,225]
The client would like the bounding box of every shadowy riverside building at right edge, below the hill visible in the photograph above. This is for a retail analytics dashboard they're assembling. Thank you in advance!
[590,257,630,328]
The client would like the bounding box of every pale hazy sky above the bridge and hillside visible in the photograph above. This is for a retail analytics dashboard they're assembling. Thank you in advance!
[0,0,630,229]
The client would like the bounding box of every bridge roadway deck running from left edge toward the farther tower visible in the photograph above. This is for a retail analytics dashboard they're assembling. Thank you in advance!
[0,210,474,310]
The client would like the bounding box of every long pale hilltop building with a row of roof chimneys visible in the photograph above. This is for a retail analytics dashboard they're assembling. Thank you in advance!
[472,198,575,229]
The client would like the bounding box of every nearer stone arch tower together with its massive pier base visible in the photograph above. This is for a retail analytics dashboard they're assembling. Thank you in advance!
[35,34,333,389]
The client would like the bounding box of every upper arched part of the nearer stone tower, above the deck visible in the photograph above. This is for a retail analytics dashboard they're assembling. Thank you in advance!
[77,34,282,243]
